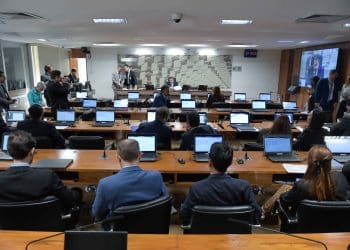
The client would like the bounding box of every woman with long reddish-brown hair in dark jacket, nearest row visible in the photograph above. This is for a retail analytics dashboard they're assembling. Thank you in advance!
[280,145,348,213]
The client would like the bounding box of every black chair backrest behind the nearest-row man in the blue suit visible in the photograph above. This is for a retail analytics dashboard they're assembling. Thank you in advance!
[113,196,172,234]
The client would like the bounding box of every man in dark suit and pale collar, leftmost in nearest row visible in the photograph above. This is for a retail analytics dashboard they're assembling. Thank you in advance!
[0,130,82,209]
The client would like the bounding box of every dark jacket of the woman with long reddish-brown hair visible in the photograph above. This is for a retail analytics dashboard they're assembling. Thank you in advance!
[280,172,348,213]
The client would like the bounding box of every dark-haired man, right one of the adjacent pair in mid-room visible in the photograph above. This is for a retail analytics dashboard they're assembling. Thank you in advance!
[180,111,216,150]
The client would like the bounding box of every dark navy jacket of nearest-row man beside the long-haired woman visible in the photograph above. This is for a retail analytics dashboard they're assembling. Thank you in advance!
[180,174,261,224]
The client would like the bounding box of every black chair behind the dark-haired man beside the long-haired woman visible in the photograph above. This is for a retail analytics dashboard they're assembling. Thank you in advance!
[182,206,255,234]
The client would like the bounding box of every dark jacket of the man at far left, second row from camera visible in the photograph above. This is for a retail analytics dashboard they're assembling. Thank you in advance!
[17,120,65,148]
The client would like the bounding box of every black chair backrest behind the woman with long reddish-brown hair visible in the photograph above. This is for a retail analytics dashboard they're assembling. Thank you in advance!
[297,200,350,233]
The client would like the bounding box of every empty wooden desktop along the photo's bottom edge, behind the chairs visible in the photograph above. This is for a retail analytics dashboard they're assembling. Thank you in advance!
[0,230,350,250]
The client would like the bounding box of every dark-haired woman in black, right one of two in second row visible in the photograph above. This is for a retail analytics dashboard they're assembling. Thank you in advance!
[295,109,329,151]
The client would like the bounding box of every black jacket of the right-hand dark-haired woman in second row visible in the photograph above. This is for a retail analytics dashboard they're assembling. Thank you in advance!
[295,128,329,151]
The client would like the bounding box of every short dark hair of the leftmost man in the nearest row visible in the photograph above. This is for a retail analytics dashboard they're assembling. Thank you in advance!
[7,130,35,160]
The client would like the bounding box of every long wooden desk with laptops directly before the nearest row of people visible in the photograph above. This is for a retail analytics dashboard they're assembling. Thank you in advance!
[0,149,307,186]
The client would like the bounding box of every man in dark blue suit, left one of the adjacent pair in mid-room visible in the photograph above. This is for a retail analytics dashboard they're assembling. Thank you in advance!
[136,107,171,150]
